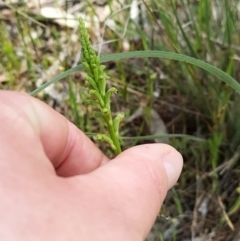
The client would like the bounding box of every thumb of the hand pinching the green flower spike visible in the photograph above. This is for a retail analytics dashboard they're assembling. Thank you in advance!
[68,144,183,240]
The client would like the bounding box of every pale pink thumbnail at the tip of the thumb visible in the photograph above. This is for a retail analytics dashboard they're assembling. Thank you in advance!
[163,151,183,188]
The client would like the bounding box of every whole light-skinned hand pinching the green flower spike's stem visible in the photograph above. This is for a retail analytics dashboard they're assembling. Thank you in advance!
[0,91,182,241]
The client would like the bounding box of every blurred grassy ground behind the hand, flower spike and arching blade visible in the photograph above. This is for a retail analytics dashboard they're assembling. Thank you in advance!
[0,0,240,241]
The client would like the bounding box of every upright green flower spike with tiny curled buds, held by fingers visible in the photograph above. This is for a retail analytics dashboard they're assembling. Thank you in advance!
[79,19,123,154]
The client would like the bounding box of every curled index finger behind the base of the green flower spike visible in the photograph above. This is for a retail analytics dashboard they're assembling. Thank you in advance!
[0,91,108,176]
